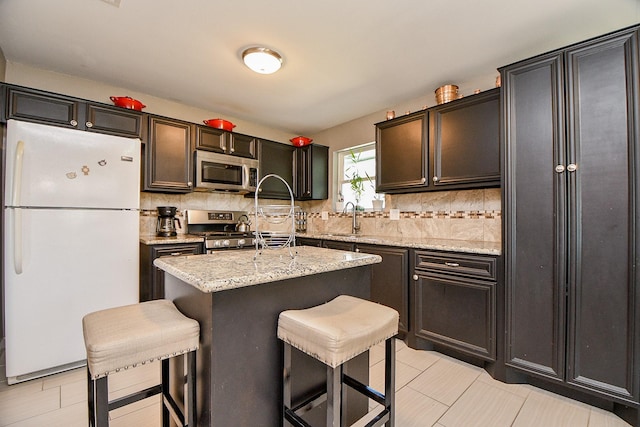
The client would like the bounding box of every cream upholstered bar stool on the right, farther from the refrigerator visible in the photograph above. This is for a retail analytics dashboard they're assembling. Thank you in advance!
[278,295,399,427]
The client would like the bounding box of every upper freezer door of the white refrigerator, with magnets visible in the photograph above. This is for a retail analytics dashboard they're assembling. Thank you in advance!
[4,120,140,209]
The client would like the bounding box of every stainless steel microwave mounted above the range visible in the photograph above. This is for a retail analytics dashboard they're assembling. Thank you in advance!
[195,150,259,194]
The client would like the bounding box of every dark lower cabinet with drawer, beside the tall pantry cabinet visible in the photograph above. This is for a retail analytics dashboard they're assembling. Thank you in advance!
[412,250,498,361]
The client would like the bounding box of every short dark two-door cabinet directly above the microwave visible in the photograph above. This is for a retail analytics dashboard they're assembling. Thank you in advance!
[196,125,257,159]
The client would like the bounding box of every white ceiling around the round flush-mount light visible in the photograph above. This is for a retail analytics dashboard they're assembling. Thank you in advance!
[0,0,640,135]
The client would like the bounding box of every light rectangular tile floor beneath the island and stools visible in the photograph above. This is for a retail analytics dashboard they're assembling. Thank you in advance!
[0,341,629,427]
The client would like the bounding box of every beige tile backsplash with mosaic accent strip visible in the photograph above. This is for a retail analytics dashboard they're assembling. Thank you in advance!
[140,188,502,242]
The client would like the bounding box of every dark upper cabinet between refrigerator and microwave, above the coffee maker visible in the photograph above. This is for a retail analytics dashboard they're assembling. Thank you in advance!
[143,115,195,193]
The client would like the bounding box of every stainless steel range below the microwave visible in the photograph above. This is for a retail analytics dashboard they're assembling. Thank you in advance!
[185,209,255,254]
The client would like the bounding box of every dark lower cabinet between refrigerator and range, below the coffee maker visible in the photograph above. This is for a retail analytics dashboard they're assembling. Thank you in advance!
[140,243,202,302]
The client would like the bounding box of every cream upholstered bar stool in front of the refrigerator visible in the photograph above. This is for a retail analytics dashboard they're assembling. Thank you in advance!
[82,300,200,427]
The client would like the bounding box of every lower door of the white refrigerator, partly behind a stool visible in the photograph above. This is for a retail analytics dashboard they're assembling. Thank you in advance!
[4,208,139,378]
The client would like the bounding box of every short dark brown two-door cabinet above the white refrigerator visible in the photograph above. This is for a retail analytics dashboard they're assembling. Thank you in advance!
[4,85,146,138]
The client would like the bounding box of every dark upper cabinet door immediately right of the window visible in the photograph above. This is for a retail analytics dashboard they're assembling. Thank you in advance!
[376,111,429,193]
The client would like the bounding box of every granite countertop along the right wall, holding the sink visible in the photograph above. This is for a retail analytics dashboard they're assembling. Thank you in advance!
[297,233,502,255]
